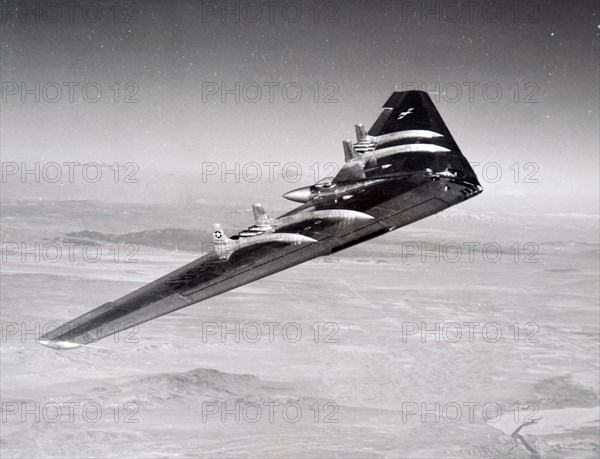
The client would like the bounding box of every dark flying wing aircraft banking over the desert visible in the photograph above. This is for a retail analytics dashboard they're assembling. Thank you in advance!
[39,91,482,349]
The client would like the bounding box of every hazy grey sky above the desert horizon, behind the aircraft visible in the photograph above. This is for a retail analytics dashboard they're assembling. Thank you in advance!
[0,0,600,213]
